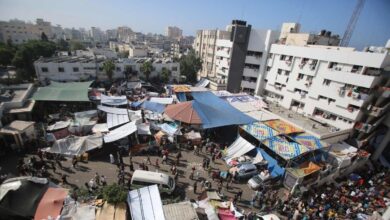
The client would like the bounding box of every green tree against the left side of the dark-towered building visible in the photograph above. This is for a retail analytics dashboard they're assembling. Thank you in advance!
[180,50,202,82]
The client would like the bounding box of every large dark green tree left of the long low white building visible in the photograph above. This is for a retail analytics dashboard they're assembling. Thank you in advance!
[12,40,57,80]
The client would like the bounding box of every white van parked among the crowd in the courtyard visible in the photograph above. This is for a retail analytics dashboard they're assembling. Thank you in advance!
[131,170,175,194]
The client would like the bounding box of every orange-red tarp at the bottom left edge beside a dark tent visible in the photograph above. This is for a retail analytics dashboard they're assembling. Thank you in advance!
[34,188,68,220]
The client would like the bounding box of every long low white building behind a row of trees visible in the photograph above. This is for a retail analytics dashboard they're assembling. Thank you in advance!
[34,56,180,83]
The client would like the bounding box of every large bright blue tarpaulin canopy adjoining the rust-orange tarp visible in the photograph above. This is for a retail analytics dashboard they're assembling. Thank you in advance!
[191,92,256,129]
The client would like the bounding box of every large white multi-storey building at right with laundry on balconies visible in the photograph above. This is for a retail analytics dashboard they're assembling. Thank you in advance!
[257,44,390,132]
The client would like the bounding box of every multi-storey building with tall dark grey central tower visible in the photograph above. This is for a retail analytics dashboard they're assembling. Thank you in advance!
[194,20,279,94]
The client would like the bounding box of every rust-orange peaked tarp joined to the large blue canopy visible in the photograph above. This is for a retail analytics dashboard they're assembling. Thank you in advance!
[165,101,202,124]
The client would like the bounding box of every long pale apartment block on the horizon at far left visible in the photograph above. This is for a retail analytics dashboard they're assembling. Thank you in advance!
[0,18,53,44]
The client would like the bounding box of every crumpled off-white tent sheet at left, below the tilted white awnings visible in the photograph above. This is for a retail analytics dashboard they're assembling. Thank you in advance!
[44,134,103,156]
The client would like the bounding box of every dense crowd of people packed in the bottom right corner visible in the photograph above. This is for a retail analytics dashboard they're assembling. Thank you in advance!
[277,168,390,220]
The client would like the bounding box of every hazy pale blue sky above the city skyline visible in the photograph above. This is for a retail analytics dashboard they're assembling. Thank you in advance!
[0,0,390,48]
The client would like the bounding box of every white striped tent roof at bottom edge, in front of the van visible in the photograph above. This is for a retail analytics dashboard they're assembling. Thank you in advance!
[127,185,165,220]
